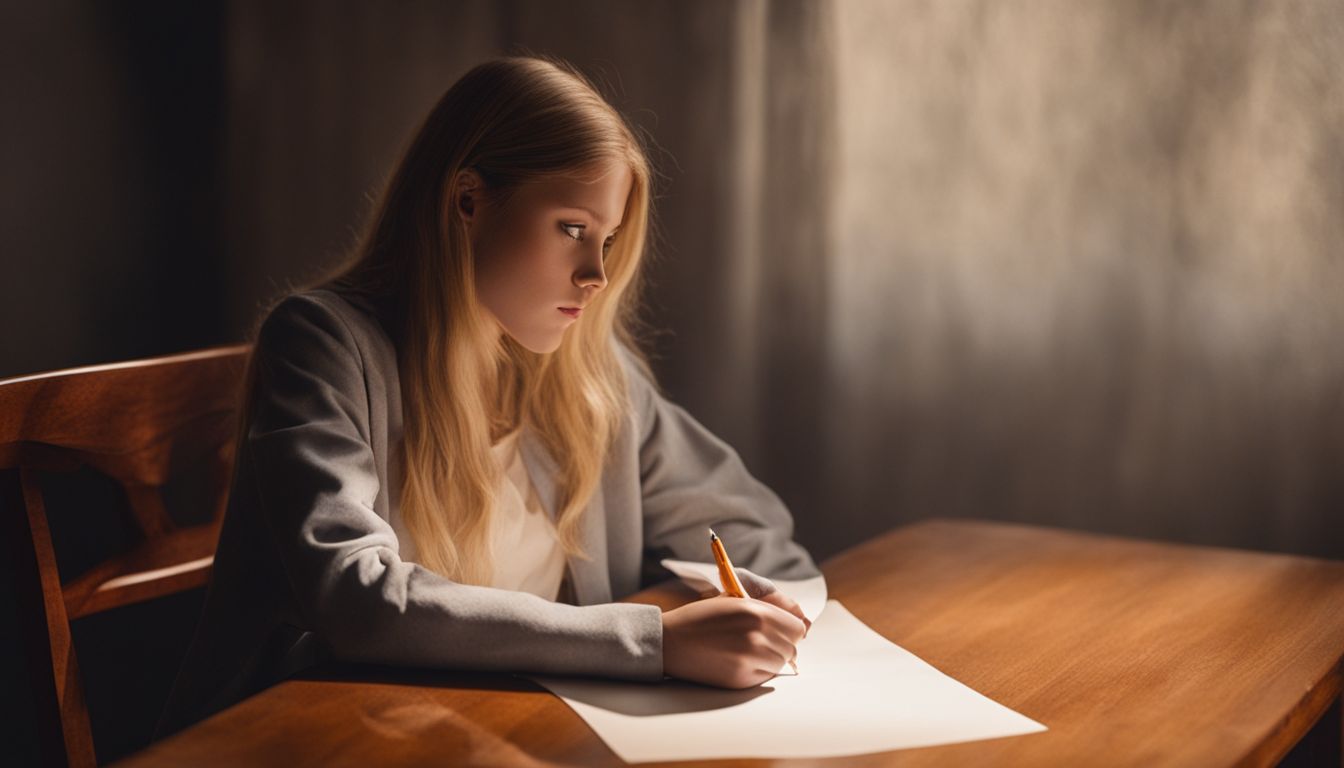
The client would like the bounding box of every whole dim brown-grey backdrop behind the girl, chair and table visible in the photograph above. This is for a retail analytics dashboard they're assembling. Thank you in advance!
[0,0,1344,763]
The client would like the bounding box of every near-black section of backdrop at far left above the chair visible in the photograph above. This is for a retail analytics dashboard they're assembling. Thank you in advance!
[0,0,233,378]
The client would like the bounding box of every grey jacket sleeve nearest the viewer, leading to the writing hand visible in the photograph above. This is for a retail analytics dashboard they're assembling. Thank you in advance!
[242,296,663,681]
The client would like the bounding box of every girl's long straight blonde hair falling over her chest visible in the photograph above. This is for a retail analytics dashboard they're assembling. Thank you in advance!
[299,56,652,584]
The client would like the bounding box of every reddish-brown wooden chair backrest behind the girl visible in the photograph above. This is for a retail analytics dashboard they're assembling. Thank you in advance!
[0,346,250,765]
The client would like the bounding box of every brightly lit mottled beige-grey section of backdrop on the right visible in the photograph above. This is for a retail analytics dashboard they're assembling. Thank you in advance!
[828,0,1344,557]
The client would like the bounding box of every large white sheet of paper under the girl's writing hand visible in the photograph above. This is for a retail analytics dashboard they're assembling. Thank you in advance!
[531,564,1046,763]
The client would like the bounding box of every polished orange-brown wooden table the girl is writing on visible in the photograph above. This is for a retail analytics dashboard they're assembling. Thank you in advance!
[118,521,1344,768]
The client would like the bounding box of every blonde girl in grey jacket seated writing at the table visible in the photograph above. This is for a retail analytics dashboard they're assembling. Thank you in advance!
[159,58,818,734]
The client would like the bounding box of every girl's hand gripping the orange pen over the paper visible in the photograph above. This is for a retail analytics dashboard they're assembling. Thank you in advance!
[663,594,806,689]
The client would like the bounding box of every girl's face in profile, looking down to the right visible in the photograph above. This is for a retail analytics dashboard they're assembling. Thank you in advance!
[456,161,632,352]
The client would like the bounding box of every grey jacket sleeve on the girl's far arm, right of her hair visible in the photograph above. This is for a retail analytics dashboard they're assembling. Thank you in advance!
[618,344,820,578]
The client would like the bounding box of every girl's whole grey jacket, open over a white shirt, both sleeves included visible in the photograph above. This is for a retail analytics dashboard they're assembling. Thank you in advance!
[159,289,818,736]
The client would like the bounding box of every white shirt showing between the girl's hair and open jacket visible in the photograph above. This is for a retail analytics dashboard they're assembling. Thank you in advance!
[390,429,564,600]
